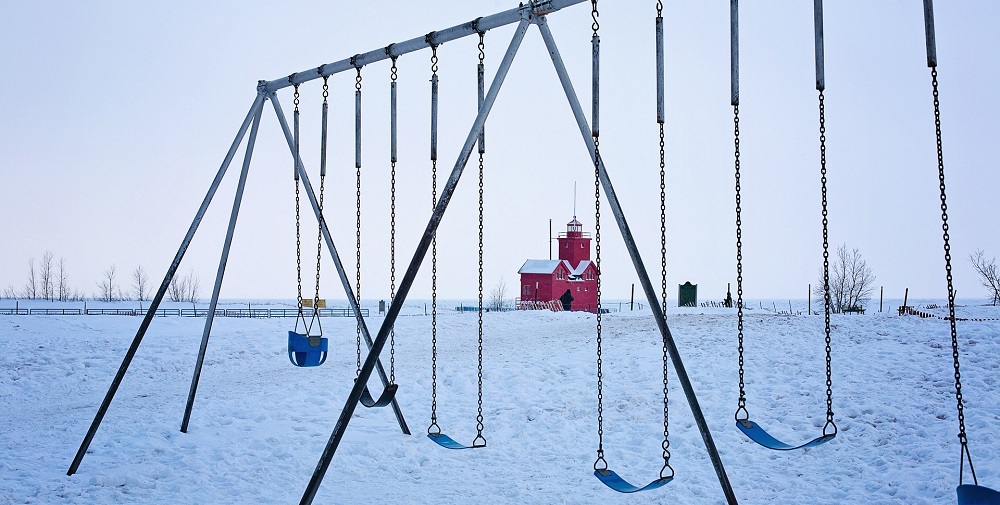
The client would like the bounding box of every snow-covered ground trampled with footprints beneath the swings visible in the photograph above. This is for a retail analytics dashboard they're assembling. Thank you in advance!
[0,302,1000,504]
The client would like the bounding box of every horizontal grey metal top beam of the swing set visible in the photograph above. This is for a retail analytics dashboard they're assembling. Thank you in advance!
[257,0,587,93]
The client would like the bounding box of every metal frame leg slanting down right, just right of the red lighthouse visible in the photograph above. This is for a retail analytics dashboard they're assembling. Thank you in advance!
[536,18,737,504]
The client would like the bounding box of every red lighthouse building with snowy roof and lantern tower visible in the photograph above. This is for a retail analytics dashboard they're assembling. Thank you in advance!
[517,217,600,311]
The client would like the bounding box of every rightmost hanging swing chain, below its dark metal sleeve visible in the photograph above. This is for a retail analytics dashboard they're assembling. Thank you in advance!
[931,66,979,485]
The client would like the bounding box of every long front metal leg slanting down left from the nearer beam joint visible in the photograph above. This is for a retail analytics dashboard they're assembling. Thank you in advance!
[296,14,531,505]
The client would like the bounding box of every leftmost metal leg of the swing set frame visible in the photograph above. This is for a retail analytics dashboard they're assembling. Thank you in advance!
[66,94,264,475]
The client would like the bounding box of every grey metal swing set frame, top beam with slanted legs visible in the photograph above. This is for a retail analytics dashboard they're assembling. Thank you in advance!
[67,0,737,504]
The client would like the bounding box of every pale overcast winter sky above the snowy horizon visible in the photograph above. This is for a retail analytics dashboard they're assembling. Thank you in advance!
[0,0,1000,300]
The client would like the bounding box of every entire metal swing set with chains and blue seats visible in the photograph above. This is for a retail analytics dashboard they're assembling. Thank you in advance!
[67,0,1000,505]
